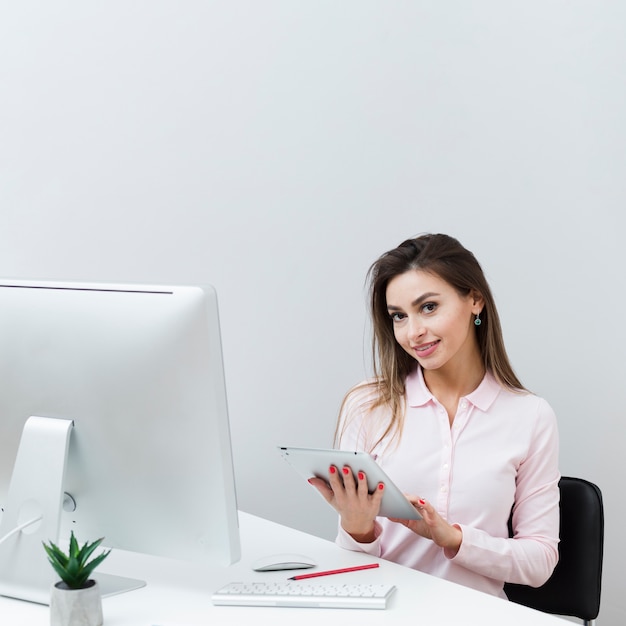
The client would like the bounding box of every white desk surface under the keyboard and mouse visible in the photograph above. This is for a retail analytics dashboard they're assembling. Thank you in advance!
[0,513,564,626]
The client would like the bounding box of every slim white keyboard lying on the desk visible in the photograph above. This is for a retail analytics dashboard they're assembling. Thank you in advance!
[211,581,395,609]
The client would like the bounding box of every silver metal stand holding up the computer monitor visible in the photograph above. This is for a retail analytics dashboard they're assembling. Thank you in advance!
[0,416,145,604]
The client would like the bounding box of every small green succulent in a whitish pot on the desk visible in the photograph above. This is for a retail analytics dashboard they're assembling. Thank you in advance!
[43,531,111,626]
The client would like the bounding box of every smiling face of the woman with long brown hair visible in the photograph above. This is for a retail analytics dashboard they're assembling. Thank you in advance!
[386,270,483,370]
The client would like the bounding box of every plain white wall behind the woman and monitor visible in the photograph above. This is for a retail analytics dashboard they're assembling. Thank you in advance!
[0,0,626,626]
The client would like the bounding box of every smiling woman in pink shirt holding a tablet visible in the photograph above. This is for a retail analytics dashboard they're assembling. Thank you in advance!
[311,235,559,597]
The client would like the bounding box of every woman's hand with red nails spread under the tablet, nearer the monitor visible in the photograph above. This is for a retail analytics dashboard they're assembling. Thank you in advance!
[309,465,384,543]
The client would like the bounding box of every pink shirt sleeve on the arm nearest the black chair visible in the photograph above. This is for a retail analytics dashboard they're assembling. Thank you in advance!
[446,400,560,587]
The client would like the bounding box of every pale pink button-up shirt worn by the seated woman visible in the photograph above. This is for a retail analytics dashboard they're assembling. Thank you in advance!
[337,367,560,597]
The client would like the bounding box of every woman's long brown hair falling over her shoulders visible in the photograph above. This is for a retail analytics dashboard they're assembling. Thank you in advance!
[335,234,526,447]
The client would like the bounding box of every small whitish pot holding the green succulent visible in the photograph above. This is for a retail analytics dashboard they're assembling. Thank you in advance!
[50,580,102,626]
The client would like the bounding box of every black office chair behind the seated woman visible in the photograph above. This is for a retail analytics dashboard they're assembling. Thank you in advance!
[504,477,604,626]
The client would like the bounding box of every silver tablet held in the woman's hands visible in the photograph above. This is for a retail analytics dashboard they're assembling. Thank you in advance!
[278,446,421,519]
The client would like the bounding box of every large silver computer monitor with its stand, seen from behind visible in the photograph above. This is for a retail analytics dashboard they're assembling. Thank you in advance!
[0,281,240,604]
